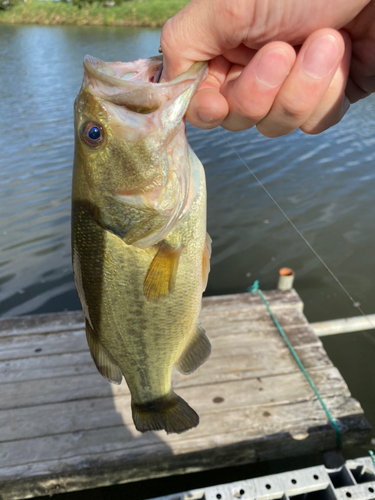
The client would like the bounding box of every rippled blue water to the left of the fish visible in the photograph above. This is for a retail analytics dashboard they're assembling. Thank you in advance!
[0,26,164,316]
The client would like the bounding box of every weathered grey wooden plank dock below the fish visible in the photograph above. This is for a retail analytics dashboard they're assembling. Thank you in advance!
[0,291,370,500]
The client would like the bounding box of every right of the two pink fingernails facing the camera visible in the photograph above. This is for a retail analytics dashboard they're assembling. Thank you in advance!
[302,35,340,80]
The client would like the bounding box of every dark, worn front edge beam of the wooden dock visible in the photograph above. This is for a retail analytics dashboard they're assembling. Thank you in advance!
[2,420,363,500]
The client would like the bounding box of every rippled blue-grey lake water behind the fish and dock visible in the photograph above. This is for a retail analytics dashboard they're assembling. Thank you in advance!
[0,25,375,498]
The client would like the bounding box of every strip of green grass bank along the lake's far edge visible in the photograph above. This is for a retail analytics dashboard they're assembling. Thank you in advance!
[0,0,189,27]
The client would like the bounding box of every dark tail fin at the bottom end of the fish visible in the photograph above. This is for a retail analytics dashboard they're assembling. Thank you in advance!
[132,391,199,434]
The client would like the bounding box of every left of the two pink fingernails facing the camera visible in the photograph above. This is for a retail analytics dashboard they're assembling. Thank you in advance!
[254,50,290,88]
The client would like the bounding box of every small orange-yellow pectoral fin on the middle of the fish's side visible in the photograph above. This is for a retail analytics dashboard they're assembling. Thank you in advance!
[143,241,184,300]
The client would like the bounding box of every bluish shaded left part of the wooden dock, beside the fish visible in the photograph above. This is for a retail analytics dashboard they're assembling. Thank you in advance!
[0,313,170,500]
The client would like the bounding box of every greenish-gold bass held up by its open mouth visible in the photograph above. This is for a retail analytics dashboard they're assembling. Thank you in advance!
[72,56,211,433]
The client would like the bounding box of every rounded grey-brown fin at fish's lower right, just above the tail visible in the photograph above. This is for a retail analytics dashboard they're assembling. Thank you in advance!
[175,324,211,375]
